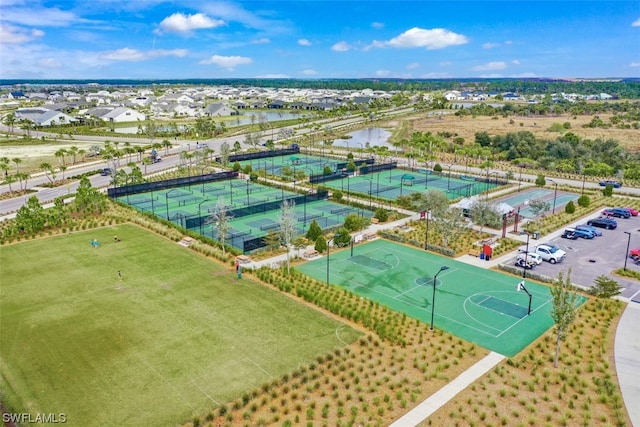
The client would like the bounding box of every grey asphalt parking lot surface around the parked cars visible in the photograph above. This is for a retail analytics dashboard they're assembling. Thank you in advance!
[509,210,640,300]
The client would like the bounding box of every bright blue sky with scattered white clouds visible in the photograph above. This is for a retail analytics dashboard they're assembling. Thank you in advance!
[0,0,640,79]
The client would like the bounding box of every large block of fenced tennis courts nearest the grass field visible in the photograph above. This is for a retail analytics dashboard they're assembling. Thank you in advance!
[117,179,373,252]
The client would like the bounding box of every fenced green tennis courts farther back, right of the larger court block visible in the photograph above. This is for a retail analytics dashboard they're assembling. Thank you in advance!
[323,169,497,200]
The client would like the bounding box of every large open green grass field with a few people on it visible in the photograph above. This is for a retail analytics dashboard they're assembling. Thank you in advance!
[0,225,359,426]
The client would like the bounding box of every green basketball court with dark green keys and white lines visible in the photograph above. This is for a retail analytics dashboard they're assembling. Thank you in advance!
[297,240,584,356]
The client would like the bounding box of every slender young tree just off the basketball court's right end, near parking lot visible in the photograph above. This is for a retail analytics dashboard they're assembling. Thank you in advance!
[550,269,578,368]
